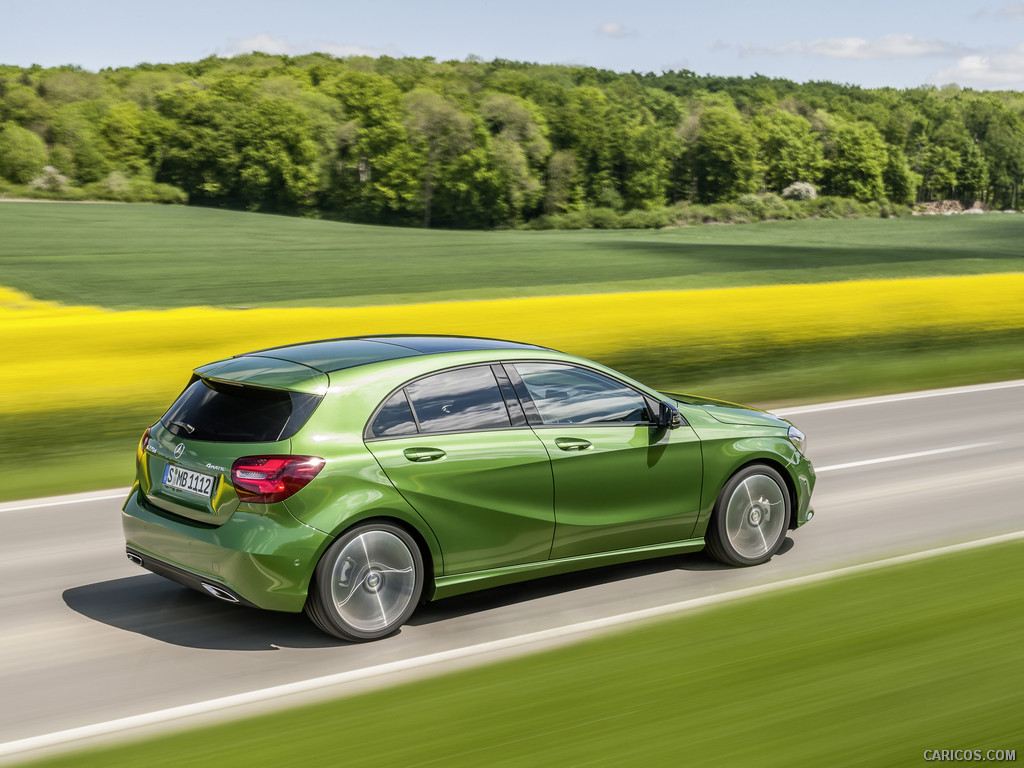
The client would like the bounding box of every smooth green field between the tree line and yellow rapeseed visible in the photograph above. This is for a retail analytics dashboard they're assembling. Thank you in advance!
[0,203,1024,308]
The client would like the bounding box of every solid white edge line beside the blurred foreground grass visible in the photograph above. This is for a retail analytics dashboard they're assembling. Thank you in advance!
[0,530,1024,758]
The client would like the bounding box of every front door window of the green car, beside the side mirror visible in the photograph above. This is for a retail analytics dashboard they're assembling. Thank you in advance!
[515,362,650,424]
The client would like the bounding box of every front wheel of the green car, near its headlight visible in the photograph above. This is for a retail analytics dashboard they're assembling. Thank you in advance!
[705,464,790,565]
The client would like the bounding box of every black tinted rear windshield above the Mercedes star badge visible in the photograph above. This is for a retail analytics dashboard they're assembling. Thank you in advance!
[160,378,321,442]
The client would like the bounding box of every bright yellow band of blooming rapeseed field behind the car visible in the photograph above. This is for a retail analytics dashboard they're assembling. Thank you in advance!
[0,273,1024,414]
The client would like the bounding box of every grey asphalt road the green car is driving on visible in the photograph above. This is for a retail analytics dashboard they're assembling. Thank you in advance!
[0,381,1024,761]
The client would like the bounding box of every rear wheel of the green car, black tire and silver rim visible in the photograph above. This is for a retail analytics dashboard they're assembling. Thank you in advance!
[305,521,424,642]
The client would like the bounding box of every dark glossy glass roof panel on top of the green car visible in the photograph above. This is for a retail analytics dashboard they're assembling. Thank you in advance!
[234,334,547,374]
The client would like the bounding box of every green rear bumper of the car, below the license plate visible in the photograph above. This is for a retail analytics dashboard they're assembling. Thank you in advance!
[121,487,329,613]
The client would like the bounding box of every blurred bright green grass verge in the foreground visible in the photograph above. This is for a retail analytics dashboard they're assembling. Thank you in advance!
[22,541,1024,768]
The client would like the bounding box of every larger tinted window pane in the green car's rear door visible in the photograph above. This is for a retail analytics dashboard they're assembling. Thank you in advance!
[406,366,512,432]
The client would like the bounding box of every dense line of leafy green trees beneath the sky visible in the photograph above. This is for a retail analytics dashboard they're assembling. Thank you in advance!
[0,53,1024,227]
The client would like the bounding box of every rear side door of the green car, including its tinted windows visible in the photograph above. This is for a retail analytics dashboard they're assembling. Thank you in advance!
[367,365,554,574]
